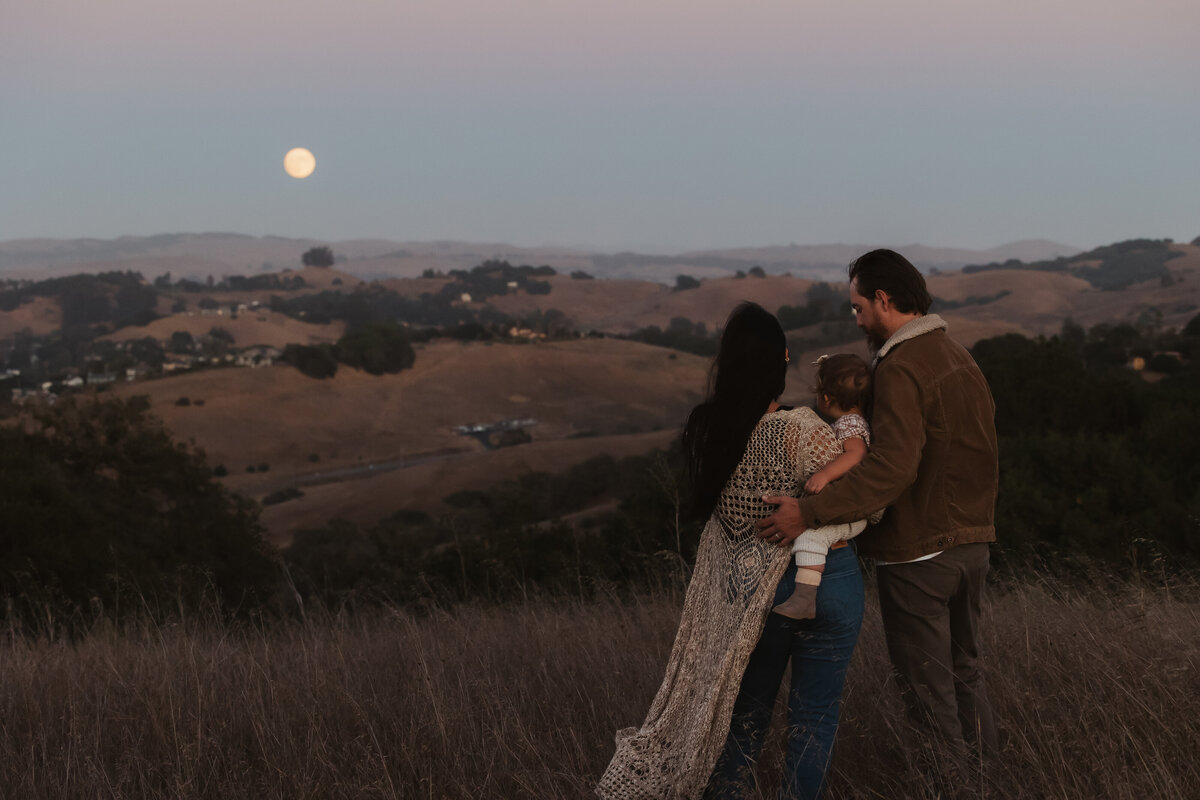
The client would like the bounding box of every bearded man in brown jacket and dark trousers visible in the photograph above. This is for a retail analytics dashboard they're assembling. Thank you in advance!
[758,249,998,751]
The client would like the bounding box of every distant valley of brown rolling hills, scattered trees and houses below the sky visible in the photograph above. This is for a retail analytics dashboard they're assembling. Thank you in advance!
[0,235,1200,543]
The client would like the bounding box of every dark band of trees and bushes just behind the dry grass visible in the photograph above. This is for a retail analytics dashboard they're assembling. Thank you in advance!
[0,309,1200,616]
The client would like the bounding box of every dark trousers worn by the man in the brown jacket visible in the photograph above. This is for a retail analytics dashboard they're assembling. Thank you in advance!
[875,542,996,752]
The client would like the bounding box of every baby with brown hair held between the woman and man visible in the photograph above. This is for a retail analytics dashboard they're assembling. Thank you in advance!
[772,354,871,619]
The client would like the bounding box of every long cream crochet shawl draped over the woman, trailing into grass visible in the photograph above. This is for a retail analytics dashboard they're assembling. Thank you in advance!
[596,408,841,800]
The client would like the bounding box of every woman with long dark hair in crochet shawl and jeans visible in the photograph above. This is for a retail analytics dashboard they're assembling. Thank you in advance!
[596,302,863,800]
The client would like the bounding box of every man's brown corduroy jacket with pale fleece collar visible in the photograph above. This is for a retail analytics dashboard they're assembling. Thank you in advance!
[800,314,1000,561]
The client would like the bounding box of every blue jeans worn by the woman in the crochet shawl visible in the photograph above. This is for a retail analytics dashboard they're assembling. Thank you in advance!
[704,546,863,800]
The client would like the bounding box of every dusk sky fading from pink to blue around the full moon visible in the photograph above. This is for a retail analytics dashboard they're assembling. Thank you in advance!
[0,0,1200,252]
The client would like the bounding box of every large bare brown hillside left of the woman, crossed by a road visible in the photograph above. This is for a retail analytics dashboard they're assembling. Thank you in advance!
[113,339,708,539]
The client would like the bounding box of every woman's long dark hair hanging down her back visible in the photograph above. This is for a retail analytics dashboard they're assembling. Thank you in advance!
[683,302,787,517]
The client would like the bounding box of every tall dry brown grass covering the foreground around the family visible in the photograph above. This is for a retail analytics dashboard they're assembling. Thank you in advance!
[0,575,1200,800]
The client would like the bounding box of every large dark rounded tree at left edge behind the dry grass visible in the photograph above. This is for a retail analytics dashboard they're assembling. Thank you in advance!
[0,397,276,615]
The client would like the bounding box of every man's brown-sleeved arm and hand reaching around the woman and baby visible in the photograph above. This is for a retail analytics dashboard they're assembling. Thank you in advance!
[757,362,925,543]
